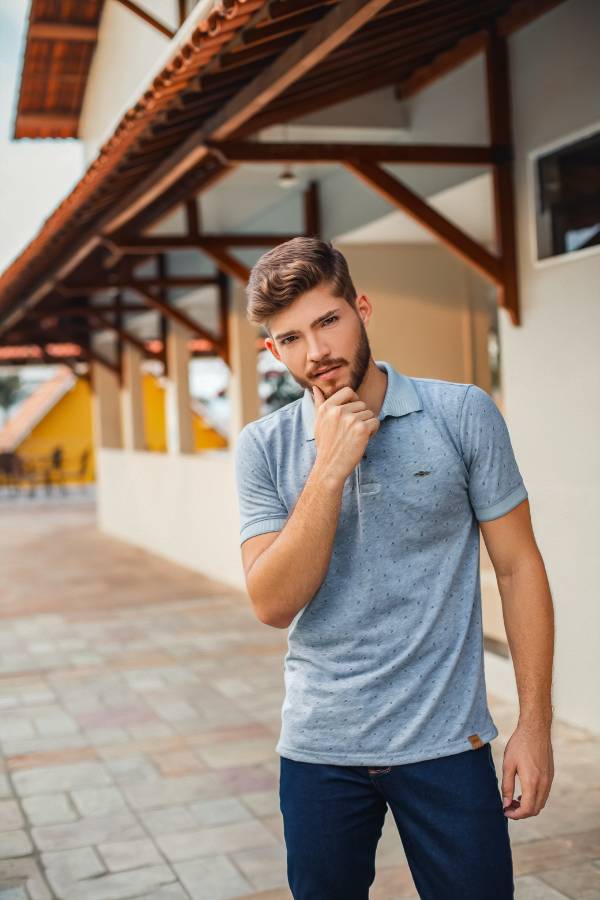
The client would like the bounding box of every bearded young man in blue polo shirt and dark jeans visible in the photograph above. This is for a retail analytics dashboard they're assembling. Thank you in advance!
[235,238,553,900]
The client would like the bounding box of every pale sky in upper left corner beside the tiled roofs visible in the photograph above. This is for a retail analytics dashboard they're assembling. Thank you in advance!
[0,0,84,272]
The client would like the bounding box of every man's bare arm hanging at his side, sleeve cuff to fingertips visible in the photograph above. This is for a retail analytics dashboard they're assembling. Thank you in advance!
[479,500,554,819]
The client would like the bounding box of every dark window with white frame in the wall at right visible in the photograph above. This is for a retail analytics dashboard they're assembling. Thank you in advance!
[535,131,600,259]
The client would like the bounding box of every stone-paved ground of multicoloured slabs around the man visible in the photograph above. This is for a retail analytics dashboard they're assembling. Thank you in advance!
[0,499,600,900]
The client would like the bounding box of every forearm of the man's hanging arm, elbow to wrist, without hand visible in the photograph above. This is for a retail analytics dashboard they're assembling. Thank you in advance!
[498,552,554,725]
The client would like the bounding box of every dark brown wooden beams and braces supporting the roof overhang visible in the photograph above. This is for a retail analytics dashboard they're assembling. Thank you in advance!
[0,0,560,364]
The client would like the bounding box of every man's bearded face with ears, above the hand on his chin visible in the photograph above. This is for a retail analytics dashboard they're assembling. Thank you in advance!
[265,284,371,398]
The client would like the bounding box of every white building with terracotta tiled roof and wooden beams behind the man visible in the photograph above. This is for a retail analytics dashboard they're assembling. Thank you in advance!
[0,0,600,729]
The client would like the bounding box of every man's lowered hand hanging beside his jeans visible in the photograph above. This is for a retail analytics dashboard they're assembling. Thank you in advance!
[502,723,554,819]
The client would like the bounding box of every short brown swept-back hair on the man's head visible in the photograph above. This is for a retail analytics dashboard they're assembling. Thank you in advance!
[246,237,356,331]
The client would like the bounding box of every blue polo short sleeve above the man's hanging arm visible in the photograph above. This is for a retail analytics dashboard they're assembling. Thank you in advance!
[459,384,527,522]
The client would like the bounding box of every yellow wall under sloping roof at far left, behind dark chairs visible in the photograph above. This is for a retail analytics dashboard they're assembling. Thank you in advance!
[16,378,95,482]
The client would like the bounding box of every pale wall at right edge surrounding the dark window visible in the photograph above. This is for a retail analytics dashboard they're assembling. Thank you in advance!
[490,0,600,730]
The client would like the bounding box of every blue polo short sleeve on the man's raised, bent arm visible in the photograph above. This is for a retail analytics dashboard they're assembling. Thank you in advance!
[234,425,288,544]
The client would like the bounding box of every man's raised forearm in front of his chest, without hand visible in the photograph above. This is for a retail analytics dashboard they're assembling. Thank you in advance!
[247,465,344,628]
